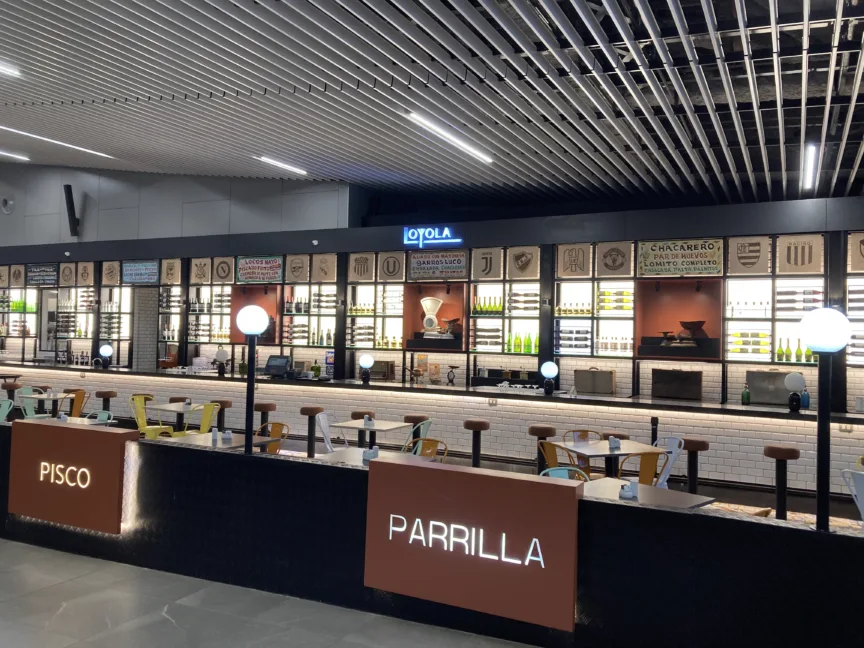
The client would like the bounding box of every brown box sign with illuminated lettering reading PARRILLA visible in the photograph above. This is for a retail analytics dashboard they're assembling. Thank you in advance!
[364,458,582,632]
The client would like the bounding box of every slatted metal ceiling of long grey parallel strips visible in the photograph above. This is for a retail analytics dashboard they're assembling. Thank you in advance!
[0,0,864,202]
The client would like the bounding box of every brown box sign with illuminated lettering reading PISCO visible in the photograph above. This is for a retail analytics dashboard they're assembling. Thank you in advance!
[9,420,138,534]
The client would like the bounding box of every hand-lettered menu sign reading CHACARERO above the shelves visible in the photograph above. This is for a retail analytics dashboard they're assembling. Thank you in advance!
[636,239,723,277]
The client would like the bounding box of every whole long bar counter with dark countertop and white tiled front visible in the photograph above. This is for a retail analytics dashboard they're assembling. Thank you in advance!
[4,363,864,493]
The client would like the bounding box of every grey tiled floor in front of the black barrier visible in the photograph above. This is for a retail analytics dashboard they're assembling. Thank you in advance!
[0,540,518,648]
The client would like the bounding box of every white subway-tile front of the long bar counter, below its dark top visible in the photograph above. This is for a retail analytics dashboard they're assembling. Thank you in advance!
[8,368,864,492]
